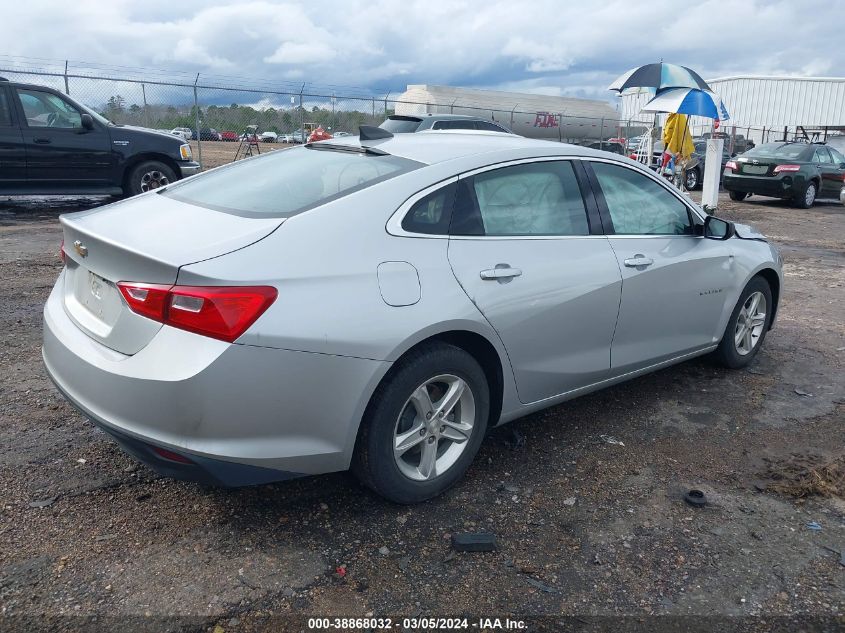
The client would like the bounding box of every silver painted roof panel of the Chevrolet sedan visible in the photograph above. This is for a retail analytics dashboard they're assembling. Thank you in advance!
[310,130,619,165]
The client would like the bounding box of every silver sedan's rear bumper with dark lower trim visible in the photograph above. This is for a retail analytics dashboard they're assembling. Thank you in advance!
[42,275,390,486]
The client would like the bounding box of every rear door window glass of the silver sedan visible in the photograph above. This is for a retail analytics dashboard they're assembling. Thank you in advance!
[451,161,590,236]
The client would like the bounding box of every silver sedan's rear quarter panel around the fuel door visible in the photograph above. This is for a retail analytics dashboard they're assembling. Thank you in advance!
[173,163,508,361]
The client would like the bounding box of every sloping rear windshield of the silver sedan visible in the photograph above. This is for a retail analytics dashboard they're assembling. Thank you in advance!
[161,147,422,218]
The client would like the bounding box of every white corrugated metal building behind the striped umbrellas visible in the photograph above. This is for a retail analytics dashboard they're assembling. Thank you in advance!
[621,76,845,135]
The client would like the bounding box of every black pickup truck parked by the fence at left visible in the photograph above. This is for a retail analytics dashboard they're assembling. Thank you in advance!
[0,77,200,196]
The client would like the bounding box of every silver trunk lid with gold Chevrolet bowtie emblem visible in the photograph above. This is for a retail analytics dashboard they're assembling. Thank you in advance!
[60,194,284,355]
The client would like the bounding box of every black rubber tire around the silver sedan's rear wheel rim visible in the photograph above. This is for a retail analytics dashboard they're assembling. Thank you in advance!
[352,343,490,504]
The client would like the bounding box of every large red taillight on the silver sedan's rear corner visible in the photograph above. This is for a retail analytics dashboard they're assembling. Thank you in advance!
[117,281,278,343]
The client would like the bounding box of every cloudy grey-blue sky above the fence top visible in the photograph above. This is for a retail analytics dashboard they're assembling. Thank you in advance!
[0,0,845,98]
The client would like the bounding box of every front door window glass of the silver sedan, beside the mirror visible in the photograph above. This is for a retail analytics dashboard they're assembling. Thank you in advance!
[592,162,694,235]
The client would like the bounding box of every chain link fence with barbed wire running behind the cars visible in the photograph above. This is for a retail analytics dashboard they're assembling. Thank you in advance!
[0,57,828,168]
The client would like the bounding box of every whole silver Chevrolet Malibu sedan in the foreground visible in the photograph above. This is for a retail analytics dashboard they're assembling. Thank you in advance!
[43,128,782,503]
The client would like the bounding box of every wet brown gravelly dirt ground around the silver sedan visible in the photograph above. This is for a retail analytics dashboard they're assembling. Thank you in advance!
[0,190,845,633]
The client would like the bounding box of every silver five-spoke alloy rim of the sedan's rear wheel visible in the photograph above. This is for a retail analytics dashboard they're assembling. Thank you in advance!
[393,374,475,481]
